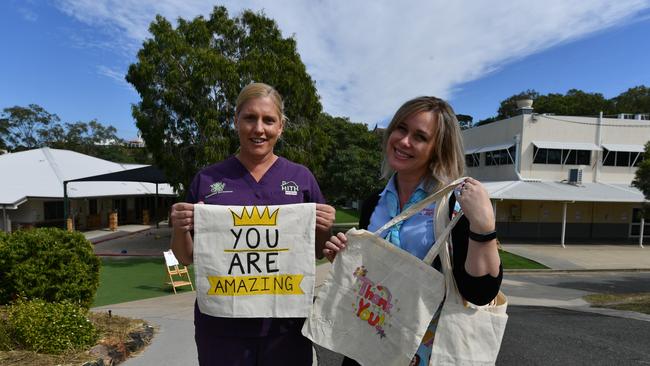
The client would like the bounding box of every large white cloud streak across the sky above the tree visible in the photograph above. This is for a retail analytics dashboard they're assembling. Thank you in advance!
[52,0,650,124]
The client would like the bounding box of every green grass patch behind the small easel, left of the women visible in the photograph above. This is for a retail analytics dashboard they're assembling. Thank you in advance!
[92,257,194,306]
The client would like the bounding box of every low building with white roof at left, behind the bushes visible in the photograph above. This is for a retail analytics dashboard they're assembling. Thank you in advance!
[0,147,176,232]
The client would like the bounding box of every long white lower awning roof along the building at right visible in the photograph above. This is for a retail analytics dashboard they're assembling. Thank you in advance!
[482,180,645,203]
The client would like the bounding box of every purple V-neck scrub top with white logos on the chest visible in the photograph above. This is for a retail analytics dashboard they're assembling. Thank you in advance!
[187,156,325,337]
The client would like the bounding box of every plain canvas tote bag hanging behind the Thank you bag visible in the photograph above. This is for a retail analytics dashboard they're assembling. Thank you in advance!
[429,199,508,366]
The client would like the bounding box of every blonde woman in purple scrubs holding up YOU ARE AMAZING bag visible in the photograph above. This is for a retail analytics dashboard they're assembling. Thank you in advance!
[171,83,335,366]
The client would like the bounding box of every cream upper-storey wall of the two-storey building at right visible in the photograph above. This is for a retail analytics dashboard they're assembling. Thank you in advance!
[463,115,650,183]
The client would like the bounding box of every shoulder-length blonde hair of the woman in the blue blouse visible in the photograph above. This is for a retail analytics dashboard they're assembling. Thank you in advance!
[381,97,465,192]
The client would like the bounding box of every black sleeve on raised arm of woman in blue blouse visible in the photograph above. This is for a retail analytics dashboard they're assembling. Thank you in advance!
[448,194,503,305]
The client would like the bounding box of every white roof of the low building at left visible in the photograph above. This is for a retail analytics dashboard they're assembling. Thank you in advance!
[0,147,174,206]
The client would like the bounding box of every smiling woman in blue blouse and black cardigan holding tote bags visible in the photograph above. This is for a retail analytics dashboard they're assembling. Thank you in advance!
[323,97,503,365]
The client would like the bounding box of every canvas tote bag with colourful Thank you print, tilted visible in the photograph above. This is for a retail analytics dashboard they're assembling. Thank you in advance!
[302,179,462,366]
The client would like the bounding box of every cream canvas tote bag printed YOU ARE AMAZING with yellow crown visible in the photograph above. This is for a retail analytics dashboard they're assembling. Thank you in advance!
[194,203,316,318]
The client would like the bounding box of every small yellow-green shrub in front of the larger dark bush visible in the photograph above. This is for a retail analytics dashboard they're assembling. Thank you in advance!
[8,300,97,354]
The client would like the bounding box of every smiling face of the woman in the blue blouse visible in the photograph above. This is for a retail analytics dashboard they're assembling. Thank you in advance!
[386,111,437,178]
